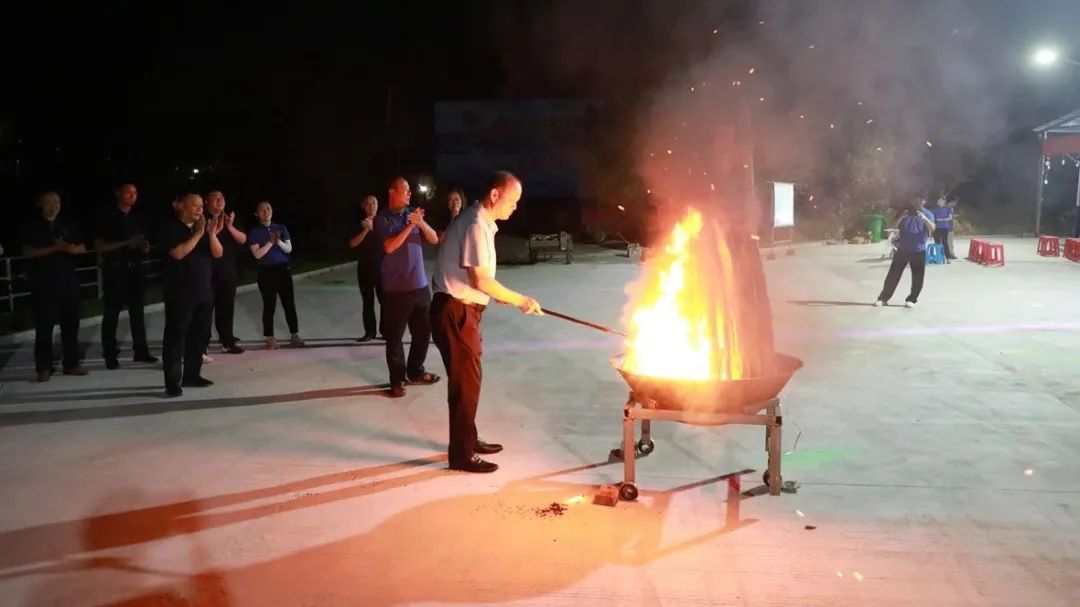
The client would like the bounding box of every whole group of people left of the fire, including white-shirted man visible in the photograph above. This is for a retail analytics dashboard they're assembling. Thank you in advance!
[7,172,542,472]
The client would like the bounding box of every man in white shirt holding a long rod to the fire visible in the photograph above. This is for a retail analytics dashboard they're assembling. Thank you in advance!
[431,172,543,472]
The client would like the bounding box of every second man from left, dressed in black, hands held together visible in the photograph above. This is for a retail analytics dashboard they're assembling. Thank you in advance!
[94,184,158,369]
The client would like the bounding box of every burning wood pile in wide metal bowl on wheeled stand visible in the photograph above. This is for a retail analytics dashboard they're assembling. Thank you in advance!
[611,210,802,501]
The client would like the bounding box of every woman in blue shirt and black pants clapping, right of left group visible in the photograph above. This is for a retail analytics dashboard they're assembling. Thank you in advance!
[247,201,303,350]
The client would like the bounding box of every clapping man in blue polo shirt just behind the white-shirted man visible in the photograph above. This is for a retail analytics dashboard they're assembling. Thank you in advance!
[375,177,438,399]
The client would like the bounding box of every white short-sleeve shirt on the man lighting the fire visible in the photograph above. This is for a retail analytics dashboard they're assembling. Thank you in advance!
[432,204,499,306]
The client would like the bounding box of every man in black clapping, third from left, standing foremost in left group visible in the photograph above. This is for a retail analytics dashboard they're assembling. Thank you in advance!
[161,193,225,396]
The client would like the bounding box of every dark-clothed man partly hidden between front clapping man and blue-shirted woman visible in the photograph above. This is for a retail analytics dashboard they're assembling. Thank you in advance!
[206,190,247,354]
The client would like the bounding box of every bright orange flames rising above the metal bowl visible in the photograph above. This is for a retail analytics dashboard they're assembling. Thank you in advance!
[622,208,743,380]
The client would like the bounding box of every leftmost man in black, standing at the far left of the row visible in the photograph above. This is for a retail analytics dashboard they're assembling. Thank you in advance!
[23,192,86,381]
